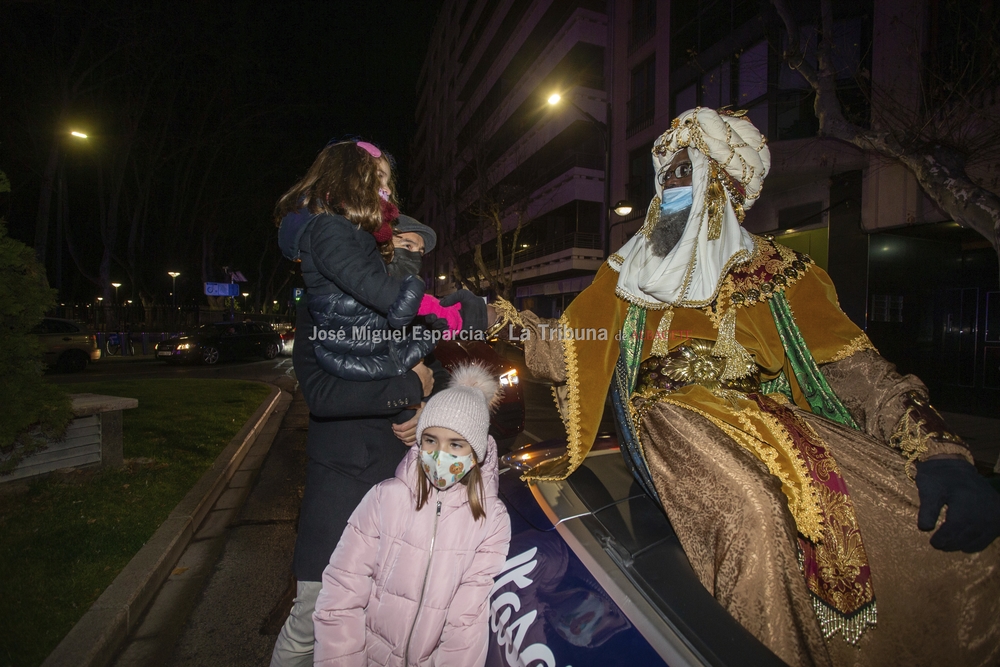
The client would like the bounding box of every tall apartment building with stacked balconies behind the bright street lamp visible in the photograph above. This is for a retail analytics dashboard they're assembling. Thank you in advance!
[411,0,608,315]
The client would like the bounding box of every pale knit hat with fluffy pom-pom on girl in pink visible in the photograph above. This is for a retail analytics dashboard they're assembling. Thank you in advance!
[417,363,501,463]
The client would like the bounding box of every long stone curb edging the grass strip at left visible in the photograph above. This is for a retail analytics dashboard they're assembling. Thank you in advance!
[42,385,282,667]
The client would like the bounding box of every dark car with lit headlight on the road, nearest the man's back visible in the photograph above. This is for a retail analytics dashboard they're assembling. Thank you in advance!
[156,322,281,364]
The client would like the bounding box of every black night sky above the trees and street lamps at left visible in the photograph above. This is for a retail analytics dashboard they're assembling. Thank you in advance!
[0,0,440,302]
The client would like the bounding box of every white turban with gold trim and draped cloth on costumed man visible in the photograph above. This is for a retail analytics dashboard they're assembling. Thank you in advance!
[608,107,771,309]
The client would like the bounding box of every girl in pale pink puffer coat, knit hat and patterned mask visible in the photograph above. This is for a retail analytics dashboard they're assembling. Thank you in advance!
[313,364,510,667]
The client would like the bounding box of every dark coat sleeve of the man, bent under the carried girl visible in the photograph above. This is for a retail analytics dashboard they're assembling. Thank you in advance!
[292,306,423,418]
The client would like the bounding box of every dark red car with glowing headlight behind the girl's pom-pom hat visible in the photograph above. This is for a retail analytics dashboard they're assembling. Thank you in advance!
[433,340,524,451]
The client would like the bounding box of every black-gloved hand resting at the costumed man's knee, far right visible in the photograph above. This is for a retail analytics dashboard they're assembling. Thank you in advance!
[917,459,1000,553]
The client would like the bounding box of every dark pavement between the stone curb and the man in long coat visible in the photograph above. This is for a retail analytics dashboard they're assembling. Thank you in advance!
[112,384,309,667]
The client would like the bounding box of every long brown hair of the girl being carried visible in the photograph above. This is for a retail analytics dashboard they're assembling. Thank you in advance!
[274,141,396,262]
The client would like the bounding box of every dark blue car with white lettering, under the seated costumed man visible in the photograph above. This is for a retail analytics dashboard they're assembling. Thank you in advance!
[486,435,784,667]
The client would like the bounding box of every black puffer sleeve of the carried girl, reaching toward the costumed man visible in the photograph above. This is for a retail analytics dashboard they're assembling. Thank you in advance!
[309,215,423,318]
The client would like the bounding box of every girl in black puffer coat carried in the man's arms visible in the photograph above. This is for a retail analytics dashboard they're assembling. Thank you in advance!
[276,141,434,381]
